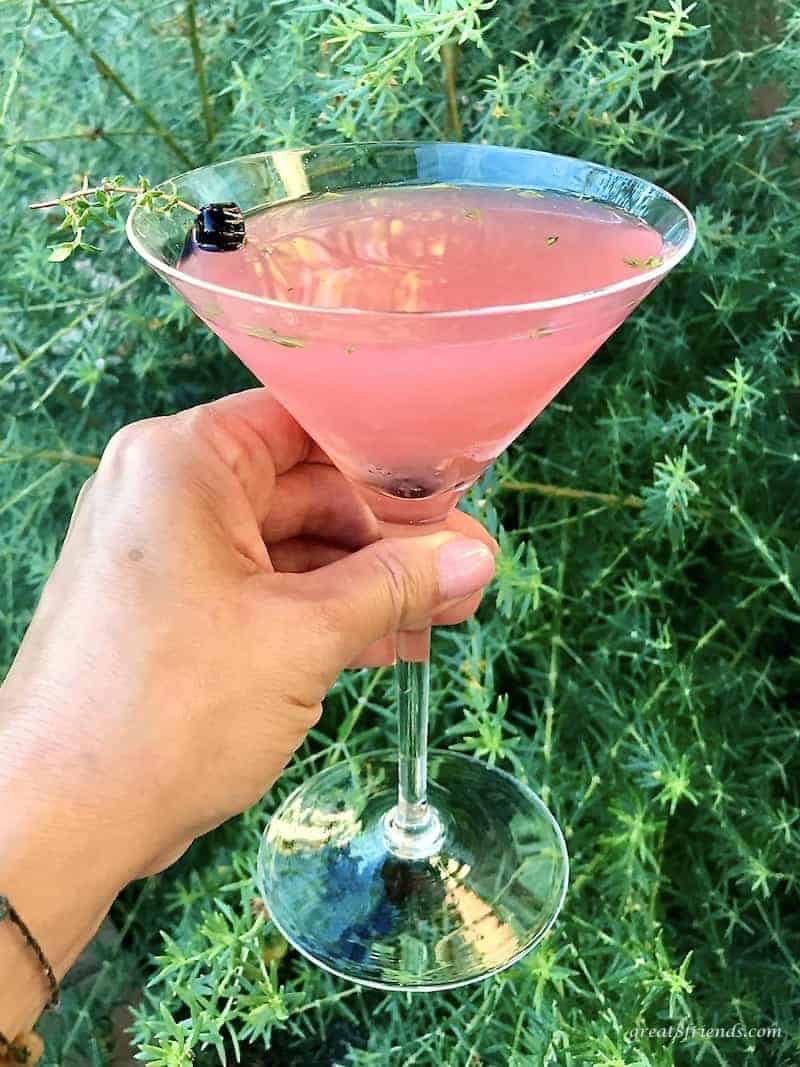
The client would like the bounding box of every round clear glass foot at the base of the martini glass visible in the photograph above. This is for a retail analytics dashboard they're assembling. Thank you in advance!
[258,752,569,990]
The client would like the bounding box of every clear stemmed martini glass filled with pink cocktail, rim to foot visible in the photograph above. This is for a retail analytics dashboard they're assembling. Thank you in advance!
[128,142,694,990]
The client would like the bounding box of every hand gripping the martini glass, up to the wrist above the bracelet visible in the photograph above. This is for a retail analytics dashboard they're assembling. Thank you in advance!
[0,389,495,895]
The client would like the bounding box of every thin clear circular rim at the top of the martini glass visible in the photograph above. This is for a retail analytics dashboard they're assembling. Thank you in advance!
[125,141,697,320]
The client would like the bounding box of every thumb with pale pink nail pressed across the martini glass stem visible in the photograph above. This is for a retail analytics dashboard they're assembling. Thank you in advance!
[293,534,495,669]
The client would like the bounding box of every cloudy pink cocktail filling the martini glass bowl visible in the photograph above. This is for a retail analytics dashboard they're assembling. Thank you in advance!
[178,185,669,522]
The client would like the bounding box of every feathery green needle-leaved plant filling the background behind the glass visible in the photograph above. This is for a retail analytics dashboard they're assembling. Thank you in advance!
[0,0,800,1067]
